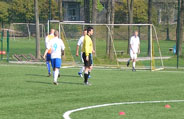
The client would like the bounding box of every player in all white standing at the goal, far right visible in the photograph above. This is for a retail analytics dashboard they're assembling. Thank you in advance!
[127,31,140,71]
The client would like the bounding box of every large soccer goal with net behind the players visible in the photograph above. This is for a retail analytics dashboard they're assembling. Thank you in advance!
[48,22,164,71]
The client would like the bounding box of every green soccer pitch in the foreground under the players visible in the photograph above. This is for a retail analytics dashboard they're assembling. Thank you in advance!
[0,64,184,119]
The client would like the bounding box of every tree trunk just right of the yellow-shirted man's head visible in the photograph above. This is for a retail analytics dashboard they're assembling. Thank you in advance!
[92,0,97,56]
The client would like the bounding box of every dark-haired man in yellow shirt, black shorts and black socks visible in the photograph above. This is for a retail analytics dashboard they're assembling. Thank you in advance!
[82,27,94,85]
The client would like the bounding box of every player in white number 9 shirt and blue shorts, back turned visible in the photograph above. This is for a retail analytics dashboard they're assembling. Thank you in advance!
[44,31,65,85]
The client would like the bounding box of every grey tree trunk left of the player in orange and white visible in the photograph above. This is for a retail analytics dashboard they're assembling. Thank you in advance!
[34,0,40,59]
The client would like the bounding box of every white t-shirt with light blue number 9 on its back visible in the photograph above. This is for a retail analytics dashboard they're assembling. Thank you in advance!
[47,37,65,59]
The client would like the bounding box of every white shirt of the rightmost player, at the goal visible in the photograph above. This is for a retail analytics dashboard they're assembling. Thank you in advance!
[130,36,140,53]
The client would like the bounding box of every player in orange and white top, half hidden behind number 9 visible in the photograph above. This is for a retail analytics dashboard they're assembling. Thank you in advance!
[45,29,55,76]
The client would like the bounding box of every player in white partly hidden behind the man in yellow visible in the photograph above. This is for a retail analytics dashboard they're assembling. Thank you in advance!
[76,29,87,77]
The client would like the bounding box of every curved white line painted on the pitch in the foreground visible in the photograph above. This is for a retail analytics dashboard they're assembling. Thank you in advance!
[63,100,184,119]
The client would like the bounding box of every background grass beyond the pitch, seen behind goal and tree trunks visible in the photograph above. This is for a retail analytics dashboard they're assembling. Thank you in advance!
[1,38,184,67]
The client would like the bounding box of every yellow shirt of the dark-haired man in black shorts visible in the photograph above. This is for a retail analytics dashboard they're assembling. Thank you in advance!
[82,35,93,56]
